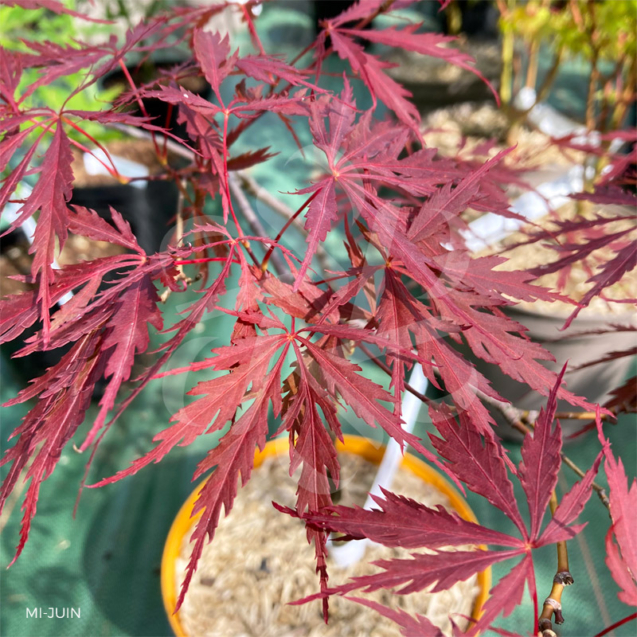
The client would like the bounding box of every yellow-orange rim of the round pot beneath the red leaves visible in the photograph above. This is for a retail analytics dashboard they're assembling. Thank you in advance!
[161,435,491,637]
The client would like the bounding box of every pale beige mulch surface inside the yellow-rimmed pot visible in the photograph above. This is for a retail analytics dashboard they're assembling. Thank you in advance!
[175,454,478,637]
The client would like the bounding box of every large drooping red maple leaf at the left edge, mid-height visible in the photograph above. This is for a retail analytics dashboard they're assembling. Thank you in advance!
[0,200,188,561]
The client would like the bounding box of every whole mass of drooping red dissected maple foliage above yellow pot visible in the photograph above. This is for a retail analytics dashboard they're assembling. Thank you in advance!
[0,0,637,635]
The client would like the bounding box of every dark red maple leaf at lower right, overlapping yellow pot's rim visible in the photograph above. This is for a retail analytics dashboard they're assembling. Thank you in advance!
[290,370,604,634]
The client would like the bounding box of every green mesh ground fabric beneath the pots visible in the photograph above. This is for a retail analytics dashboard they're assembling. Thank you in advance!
[0,7,637,637]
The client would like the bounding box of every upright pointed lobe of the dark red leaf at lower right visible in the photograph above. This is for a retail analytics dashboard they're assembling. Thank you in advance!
[519,365,566,538]
